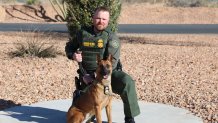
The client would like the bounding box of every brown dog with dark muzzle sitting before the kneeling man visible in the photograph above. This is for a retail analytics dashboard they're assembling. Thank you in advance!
[67,55,112,123]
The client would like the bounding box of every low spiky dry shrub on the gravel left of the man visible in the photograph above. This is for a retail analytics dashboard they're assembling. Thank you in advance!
[9,32,62,58]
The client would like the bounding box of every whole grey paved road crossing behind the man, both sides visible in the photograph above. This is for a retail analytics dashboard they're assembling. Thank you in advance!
[0,23,218,34]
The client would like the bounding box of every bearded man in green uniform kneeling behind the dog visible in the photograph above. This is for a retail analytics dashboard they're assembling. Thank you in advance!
[65,7,140,123]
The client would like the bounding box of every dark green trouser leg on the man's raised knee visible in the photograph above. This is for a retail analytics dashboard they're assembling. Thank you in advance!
[111,71,140,117]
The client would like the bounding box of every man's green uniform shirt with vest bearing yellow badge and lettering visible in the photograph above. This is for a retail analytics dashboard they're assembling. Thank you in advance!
[65,27,120,70]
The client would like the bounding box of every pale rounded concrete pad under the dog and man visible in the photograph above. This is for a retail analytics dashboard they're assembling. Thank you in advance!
[0,99,203,123]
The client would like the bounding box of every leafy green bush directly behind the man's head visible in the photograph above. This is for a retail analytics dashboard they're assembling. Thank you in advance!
[65,0,121,40]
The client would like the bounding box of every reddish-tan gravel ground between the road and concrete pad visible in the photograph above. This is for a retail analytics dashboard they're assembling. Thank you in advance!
[0,33,218,123]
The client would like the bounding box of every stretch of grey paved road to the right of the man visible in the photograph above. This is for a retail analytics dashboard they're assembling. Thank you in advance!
[119,24,218,34]
